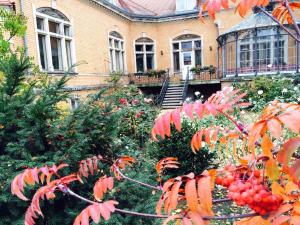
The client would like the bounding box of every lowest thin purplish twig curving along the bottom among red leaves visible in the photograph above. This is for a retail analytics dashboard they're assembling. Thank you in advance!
[64,188,258,220]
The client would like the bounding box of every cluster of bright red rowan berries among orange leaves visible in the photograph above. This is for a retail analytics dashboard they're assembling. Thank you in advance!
[216,166,283,215]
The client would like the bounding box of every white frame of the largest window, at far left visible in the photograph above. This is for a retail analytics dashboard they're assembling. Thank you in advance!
[34,9,76,72]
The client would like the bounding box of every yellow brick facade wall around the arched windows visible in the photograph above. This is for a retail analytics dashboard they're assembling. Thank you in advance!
[12,0,251,92]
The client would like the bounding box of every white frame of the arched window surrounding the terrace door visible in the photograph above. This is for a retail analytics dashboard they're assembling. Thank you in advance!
[171,37,204,73]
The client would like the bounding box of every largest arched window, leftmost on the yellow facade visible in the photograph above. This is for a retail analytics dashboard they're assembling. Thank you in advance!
[36,8,74,71]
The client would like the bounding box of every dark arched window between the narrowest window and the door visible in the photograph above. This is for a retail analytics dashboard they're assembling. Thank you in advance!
[135,37,155,73]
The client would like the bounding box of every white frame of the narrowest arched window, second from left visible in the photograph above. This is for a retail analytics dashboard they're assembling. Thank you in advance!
[108,31,126,73]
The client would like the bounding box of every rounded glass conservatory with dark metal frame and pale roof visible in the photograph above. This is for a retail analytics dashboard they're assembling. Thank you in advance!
[217,12,299,78]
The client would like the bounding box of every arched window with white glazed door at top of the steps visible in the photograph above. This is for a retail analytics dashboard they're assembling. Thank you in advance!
[172,34,202,71]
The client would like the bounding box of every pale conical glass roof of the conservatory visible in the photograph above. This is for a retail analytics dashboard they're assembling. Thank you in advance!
[222,12,300,35]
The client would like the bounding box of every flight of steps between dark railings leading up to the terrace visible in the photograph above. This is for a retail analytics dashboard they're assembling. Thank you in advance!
[161,85,184,109]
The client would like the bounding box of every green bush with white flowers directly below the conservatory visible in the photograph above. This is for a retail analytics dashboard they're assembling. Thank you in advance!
[235,76,300,112]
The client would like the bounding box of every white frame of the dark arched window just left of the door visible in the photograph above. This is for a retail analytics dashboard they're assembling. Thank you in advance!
[133,40,157,73]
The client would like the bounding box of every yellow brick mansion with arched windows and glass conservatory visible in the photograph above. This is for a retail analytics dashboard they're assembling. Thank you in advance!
[0,0,299,109]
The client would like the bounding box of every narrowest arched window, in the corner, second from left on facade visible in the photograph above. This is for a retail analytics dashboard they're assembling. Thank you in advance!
[109,31,125,72]
